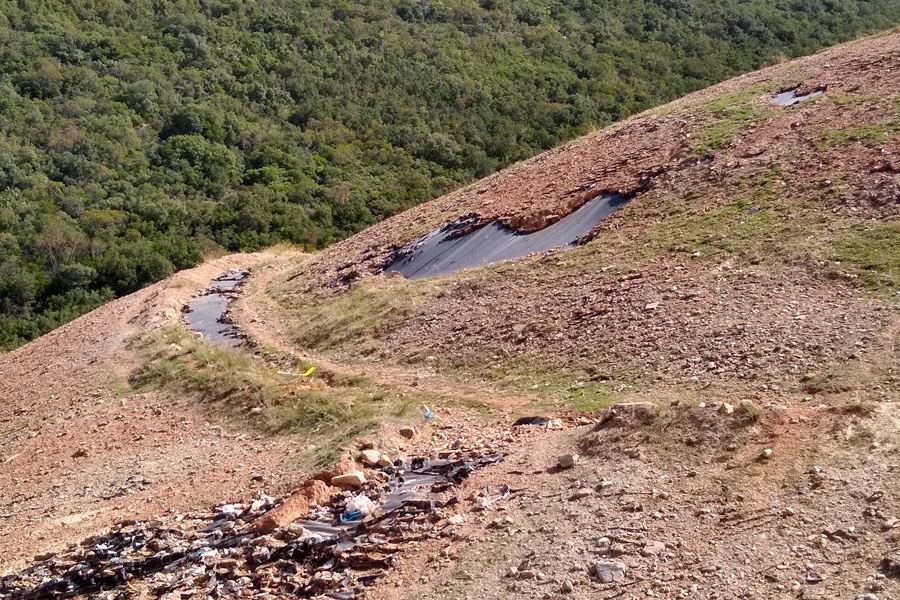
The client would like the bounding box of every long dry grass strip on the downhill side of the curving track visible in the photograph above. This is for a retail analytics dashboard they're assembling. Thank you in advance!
[131,326,419,467]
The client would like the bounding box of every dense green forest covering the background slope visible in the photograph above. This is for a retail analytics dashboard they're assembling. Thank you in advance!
[0,0,900,350]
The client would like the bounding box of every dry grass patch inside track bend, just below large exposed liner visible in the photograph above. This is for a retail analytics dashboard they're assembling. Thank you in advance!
[292,277,441,353]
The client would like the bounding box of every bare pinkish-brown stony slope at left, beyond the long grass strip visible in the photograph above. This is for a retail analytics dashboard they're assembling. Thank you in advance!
[0,255,310,572]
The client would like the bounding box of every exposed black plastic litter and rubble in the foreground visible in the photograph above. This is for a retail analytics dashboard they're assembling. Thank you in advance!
[0,454,502,600]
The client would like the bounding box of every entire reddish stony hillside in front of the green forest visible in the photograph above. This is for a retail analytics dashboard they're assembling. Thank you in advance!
[0,31,900,600]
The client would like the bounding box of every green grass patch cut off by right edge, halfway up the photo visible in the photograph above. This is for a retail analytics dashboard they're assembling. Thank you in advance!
[829,221,900,295]
